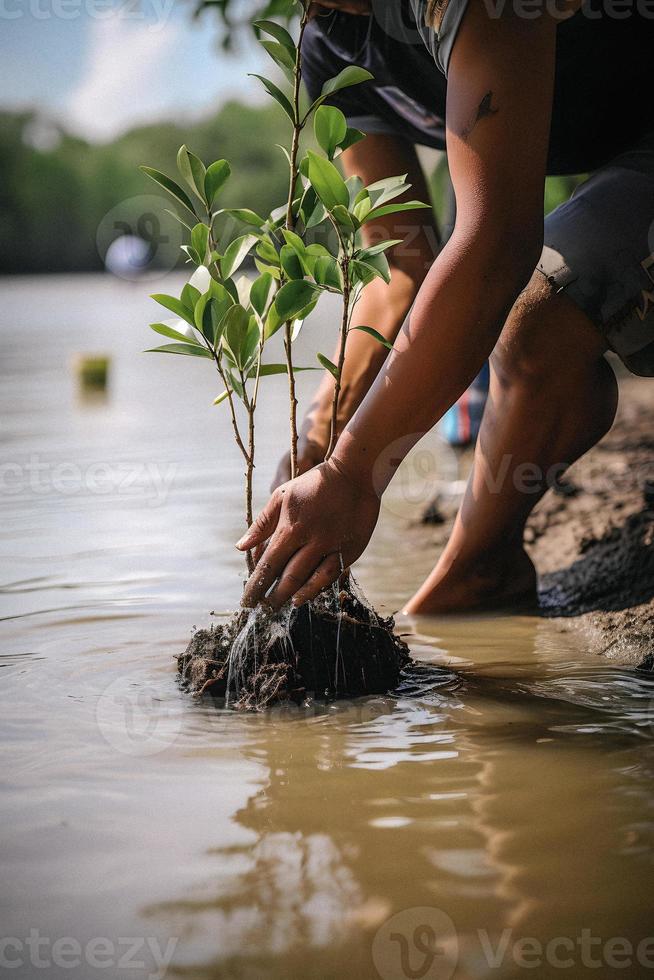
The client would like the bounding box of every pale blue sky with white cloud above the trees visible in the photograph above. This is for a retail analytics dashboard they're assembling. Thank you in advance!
[0,0,266,141]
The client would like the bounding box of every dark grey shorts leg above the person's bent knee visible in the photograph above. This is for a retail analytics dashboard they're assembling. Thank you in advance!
[538,133,654,378]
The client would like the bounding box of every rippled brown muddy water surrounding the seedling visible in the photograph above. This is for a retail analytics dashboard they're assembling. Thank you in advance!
[0,277,654,980]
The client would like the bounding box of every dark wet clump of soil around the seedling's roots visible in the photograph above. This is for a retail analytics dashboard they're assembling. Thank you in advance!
[177,589,410,709]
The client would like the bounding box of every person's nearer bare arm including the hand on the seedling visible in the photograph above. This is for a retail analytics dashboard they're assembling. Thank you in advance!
[239,2,556,606]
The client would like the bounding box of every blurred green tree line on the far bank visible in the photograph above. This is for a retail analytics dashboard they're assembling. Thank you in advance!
[0,102,578,274]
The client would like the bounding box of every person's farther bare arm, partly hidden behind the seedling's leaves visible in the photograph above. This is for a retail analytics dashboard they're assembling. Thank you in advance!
[271,135,439,490]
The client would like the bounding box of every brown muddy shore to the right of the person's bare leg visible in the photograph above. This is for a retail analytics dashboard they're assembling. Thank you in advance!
[422,377,654,669]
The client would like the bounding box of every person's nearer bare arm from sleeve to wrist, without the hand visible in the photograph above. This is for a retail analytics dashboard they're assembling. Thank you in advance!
[334,4,555,493]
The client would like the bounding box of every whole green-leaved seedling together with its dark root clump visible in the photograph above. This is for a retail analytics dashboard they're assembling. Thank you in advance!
[142,0,426,706]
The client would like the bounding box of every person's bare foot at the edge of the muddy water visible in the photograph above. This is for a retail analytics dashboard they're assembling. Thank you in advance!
[403,548,538,616]
